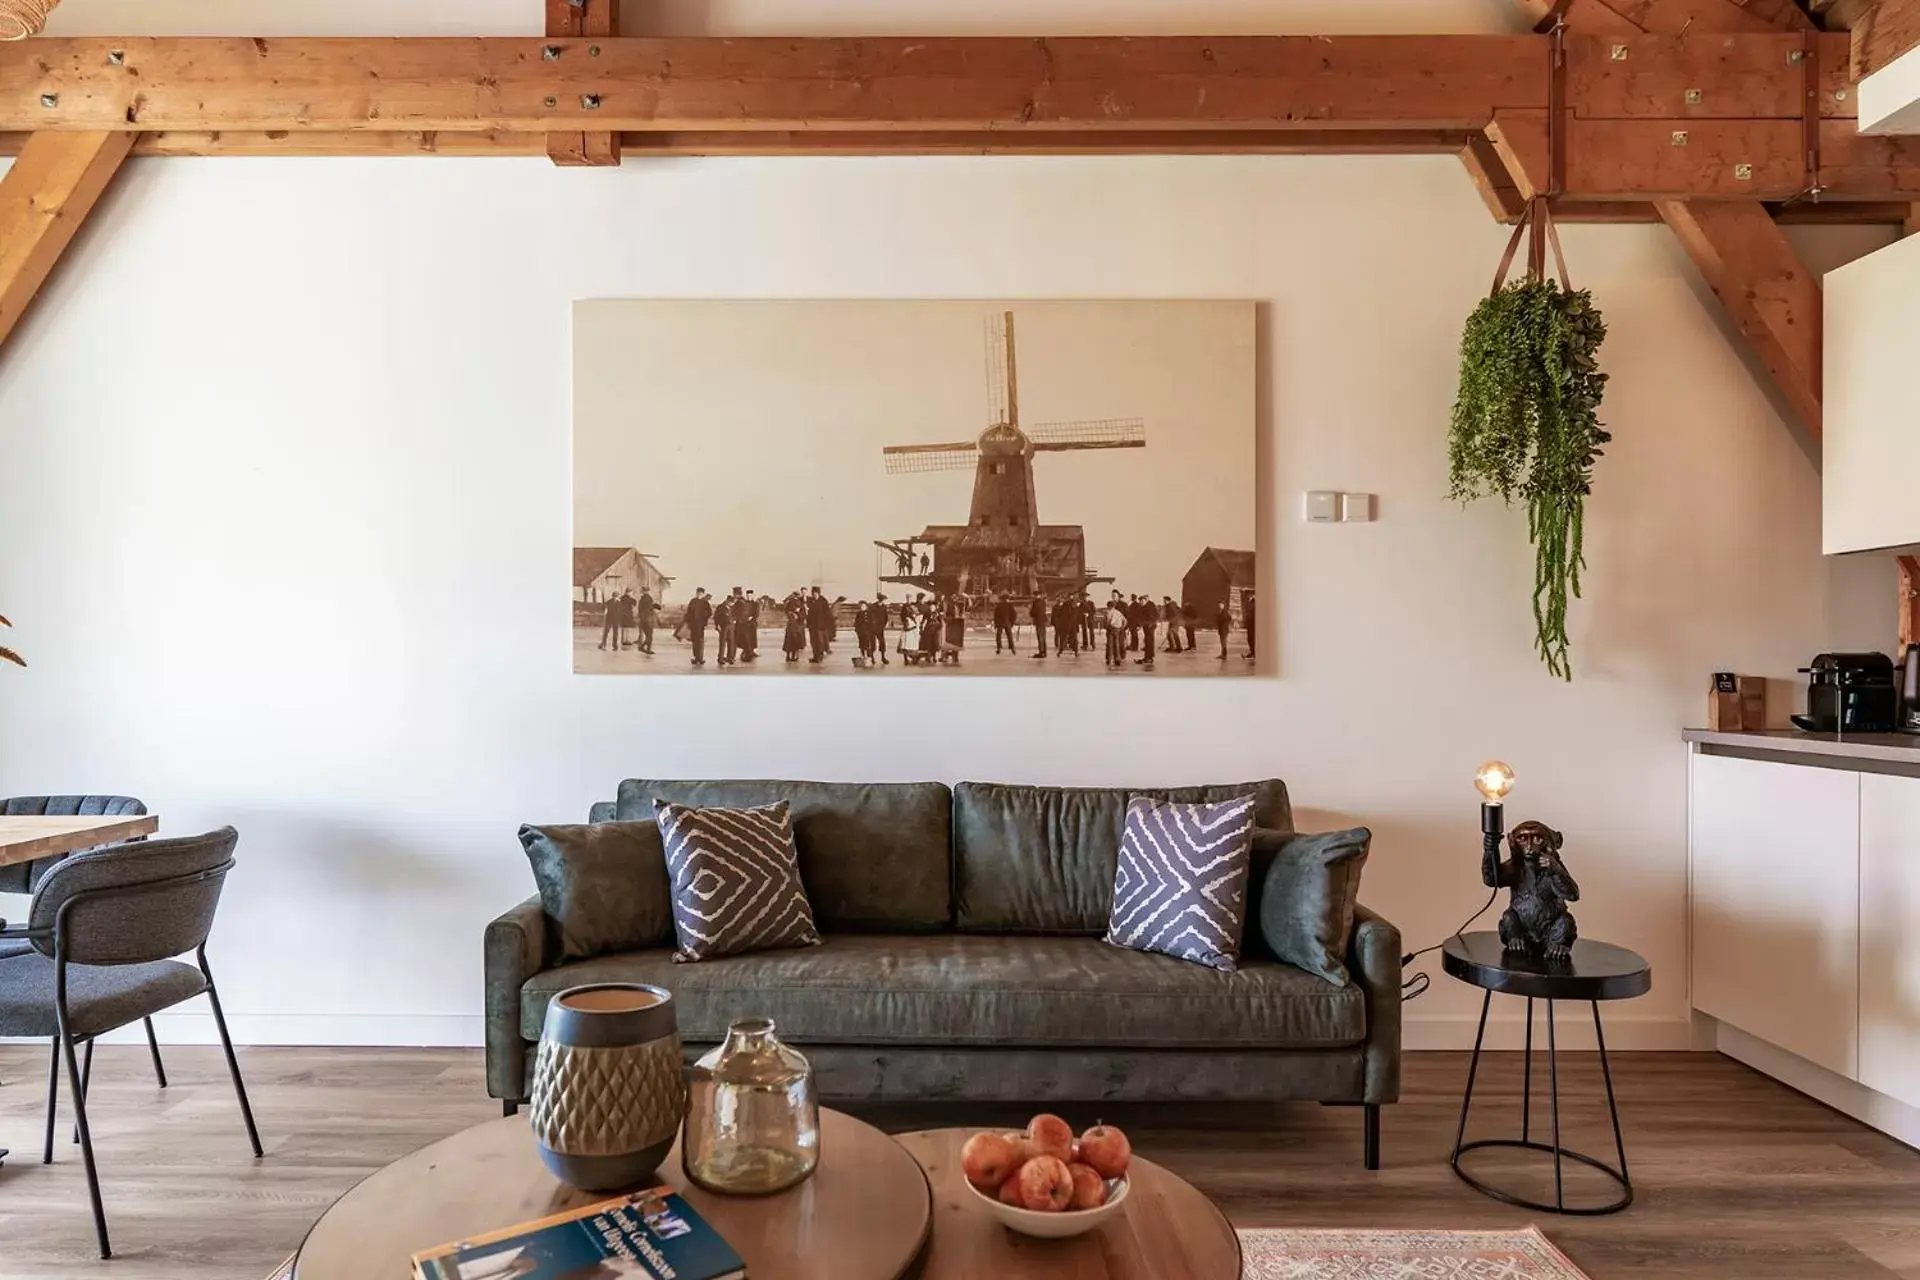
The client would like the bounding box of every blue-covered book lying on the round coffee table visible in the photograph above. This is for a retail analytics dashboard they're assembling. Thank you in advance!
[413,1186,747,1280]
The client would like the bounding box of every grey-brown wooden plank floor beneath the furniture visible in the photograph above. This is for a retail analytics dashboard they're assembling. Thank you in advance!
[0,1046,1920,1280]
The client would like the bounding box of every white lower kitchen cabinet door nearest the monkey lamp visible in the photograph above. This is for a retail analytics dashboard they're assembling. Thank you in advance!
[1692,752,1858,1079]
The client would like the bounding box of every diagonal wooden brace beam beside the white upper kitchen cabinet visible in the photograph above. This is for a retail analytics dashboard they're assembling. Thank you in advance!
[1657,200,1820,439]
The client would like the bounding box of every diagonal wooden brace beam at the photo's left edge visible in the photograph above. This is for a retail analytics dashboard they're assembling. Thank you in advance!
[0,132,132,344]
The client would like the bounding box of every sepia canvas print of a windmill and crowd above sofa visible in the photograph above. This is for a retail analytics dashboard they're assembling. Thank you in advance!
[572,299,1261,679]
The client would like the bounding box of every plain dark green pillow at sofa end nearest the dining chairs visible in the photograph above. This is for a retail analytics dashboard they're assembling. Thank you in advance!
[520,819,674,961]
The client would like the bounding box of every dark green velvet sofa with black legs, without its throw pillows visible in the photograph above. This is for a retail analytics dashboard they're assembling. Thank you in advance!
[486,779,1400,1167]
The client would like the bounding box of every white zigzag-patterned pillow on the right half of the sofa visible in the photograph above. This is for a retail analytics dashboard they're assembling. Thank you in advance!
[1106,796,1254,973]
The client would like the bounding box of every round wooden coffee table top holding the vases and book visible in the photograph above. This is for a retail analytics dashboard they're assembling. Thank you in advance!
[292,1111,936,1280]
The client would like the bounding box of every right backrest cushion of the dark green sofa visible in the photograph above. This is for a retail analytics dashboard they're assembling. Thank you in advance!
[952,779,1294,936]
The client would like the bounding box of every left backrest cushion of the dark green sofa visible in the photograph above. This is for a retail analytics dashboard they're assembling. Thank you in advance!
[614,777,952,933]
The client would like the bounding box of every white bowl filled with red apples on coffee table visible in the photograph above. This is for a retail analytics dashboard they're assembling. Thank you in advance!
[960,1115,1133,1240]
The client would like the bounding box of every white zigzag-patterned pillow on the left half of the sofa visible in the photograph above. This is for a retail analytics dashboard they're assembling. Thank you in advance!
[655,800,820,961]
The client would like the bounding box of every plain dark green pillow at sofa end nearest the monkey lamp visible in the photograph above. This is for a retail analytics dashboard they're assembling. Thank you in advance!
[1254,827,1373,986]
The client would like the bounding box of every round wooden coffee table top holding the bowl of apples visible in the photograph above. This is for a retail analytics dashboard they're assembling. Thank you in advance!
[898,1128,1240,1280]
